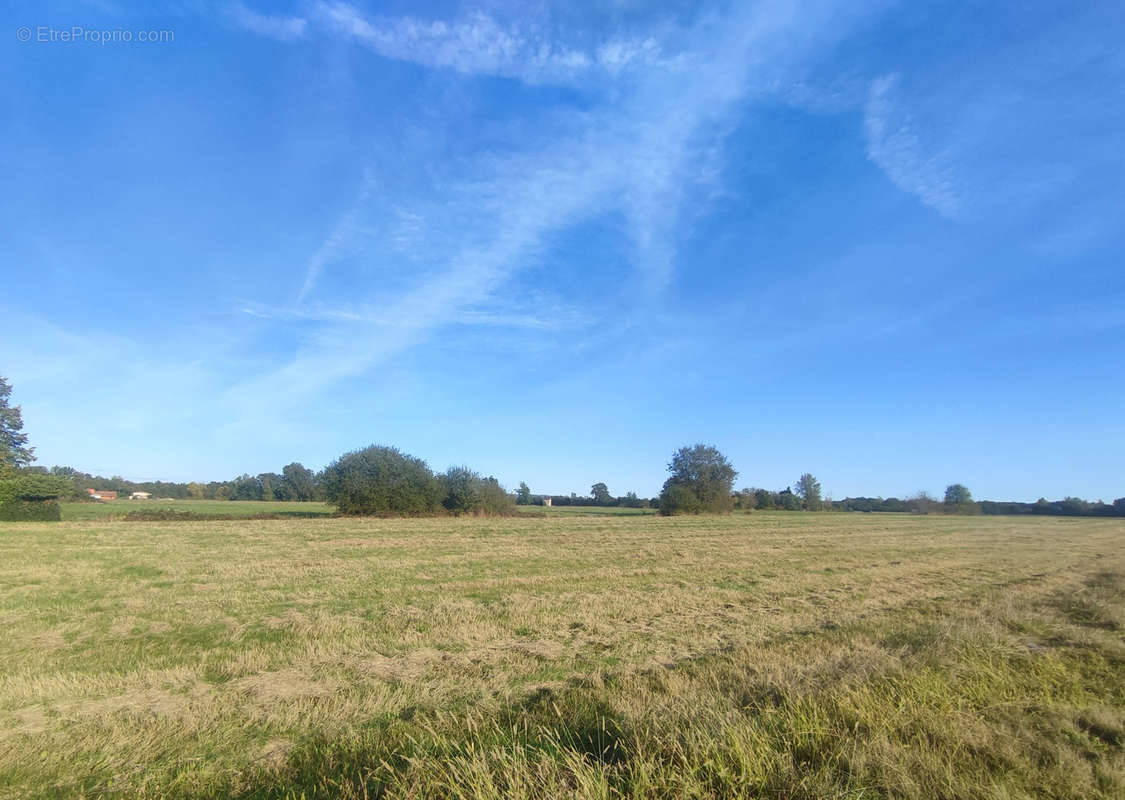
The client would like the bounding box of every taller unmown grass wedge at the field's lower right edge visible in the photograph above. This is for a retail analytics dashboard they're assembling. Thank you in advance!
[164,573,1125,800]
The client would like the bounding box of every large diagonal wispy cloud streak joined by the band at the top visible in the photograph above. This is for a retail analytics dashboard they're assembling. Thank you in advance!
[231,2,882,407]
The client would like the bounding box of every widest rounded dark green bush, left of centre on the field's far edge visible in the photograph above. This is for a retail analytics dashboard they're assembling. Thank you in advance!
[323,444,444,514]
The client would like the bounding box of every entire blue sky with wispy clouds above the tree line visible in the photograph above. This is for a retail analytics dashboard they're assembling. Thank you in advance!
[0,0,1125,501]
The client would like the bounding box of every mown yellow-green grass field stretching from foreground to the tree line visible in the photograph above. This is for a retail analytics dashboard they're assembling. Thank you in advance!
[0,513,1125,800]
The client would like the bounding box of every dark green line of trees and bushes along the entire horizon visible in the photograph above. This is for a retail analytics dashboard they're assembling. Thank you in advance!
[0,377,1125,516]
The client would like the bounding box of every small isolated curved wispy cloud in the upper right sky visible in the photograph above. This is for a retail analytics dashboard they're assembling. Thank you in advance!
[864,75,962,218]
